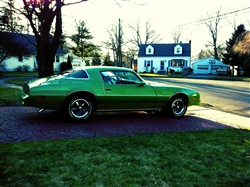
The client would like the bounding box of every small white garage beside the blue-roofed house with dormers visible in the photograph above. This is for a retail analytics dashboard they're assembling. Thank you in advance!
[191,57,228,74]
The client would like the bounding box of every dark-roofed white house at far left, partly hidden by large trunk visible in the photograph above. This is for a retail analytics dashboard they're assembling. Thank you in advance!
[0,33,65,71]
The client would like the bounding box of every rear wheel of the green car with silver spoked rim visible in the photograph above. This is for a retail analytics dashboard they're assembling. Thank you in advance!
[64,95,94,122]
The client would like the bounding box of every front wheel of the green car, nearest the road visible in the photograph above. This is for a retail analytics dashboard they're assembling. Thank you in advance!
[165,96,187,118]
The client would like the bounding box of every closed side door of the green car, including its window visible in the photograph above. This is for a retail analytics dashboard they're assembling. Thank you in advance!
[102,71,156,110]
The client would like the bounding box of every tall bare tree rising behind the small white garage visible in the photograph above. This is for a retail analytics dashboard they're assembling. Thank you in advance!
[200,9,222,59]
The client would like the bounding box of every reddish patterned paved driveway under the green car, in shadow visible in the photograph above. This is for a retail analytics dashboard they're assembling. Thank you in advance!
[0,107,231,143]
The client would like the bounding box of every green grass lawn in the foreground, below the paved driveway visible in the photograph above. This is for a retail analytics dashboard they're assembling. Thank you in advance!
[0,129,250,187]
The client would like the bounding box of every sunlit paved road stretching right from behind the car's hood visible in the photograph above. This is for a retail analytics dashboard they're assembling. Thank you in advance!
[146,78,250,117]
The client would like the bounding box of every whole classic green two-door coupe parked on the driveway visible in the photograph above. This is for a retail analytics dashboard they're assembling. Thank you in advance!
[21,66,200,121]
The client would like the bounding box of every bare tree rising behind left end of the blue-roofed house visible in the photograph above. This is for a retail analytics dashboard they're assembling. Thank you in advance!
[129,19,161,49]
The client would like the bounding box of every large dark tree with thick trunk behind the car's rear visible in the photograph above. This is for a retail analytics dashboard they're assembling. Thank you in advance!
[1,0,87,77]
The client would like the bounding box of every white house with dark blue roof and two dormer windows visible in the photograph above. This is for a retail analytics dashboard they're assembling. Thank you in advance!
[137,41,191,74]
